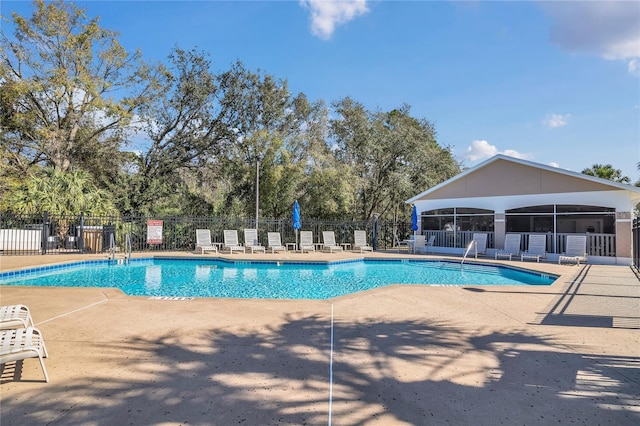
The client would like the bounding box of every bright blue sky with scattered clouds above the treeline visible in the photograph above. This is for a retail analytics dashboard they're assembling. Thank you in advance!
[5,0,640,182]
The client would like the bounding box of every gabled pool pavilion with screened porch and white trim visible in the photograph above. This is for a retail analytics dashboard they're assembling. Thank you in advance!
[407,155,640,265]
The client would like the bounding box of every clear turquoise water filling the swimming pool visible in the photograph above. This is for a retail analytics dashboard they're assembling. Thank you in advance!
[0,258,557,299]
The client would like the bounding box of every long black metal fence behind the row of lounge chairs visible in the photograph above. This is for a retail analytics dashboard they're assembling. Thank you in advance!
[0,212,412,255]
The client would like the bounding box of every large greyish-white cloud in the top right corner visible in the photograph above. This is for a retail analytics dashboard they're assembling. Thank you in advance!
[539,0,640,73]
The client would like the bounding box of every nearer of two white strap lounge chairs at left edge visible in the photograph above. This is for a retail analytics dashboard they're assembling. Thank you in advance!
[0,327,49,382]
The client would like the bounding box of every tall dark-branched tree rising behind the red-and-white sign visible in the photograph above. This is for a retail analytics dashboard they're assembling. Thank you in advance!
[120,48,228,214]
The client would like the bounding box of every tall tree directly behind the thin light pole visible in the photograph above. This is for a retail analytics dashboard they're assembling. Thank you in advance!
[218,62,313,217]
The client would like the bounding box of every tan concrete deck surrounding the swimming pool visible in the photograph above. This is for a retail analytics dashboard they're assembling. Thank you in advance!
[0,253,640,426]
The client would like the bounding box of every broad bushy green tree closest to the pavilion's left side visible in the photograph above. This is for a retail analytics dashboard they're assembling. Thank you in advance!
[331,98,460,220]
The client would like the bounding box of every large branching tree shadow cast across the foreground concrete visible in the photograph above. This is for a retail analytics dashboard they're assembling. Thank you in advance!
[2,316,640,426]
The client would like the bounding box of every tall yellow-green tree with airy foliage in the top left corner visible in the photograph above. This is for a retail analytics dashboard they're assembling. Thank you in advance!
[0,0,148,173]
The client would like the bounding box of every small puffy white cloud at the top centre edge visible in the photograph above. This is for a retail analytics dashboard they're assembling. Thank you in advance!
[300,0,369,40]
